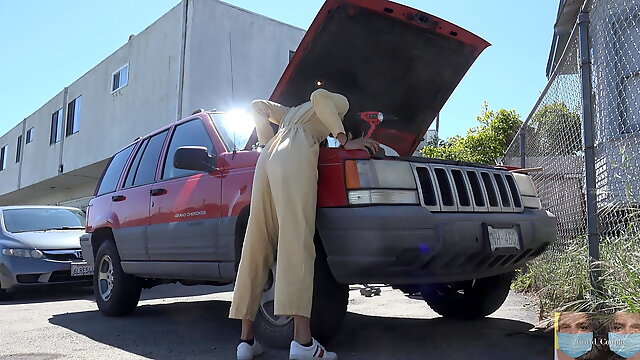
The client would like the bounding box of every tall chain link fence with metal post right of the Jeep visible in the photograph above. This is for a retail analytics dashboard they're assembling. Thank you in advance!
[502,0,640,298]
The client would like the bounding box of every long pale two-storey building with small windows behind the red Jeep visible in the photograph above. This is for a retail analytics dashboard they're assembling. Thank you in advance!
[0,0,304,207]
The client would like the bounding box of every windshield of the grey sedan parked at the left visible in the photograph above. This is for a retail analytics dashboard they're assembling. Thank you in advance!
[2,208,86,233]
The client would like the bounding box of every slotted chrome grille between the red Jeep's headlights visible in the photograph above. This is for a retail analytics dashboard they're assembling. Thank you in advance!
[413,163,523,212]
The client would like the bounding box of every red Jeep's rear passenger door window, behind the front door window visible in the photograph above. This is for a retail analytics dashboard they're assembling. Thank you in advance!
[125,131,168,187]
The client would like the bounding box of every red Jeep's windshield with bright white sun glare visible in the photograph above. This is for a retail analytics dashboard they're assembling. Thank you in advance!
[209,111,256,150]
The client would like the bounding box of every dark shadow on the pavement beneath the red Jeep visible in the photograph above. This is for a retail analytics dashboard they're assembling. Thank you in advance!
[49,300,553,360]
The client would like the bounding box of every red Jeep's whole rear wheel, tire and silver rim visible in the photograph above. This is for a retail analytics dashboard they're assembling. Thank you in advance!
[93,241,142,316]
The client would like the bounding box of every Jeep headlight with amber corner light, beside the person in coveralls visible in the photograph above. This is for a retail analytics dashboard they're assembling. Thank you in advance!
[345,160,419,205]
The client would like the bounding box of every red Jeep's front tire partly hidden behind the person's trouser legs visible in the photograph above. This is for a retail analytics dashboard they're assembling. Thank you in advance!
[254,242,349,349]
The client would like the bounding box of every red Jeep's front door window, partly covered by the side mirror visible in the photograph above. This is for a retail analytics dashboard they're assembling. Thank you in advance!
[162,118,215,179]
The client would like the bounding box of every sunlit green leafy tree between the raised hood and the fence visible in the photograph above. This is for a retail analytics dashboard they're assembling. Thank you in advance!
[420,102,522,164]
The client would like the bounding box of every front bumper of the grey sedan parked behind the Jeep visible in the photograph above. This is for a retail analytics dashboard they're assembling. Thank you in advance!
[0,255,93,290]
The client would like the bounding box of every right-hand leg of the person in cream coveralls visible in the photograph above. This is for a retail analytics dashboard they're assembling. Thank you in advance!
[267,134,318,318]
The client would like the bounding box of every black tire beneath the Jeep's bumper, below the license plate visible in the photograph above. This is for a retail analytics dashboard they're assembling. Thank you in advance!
[421,271,514,319]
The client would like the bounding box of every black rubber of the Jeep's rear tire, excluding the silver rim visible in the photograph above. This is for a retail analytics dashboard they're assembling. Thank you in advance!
[93,240,142,316]
